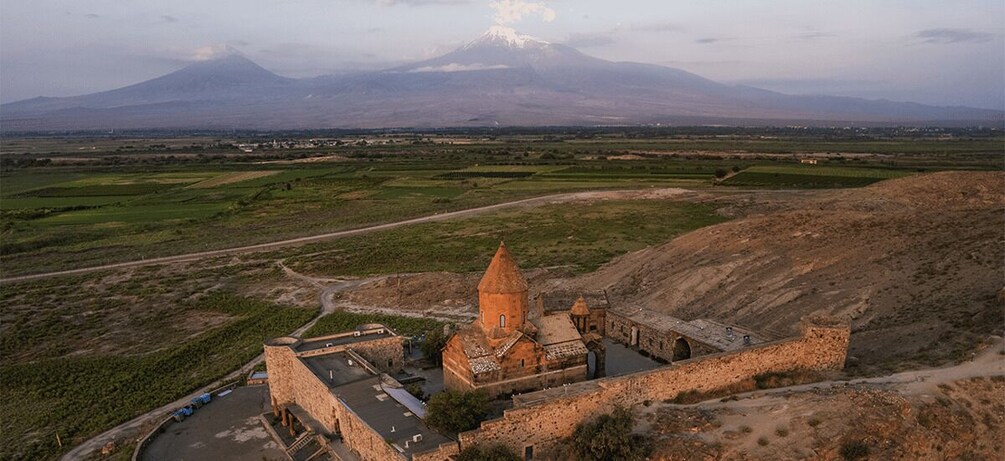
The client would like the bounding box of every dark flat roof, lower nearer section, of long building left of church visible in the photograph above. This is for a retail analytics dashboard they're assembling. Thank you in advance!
[333,377,450,458]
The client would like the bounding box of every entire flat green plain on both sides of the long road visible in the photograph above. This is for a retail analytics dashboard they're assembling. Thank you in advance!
[0,131,1003,459]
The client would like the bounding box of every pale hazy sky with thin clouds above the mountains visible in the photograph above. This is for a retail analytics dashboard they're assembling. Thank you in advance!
[0,0,1005,108]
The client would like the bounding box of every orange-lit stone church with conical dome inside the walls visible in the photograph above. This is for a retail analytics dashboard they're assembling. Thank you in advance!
[443,244,589,397]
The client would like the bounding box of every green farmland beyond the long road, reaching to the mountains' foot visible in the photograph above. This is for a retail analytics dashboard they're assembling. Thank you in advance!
[0,129,1003,276]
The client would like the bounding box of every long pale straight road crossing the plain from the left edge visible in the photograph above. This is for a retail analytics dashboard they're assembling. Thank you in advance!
[0,192,595,284]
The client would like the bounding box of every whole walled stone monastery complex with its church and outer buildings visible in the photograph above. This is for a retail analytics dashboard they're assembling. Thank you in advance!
[264,244,849,461]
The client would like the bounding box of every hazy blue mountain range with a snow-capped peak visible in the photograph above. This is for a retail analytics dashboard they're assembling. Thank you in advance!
[0,26,1005,132]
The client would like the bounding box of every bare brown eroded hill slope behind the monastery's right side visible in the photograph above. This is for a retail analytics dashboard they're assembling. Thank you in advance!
[560,173,1005,372]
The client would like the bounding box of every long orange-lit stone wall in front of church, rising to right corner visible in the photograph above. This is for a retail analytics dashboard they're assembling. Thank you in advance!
[428,323,849,459]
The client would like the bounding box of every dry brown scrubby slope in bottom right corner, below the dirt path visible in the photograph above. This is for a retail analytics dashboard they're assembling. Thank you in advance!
[636,376,1005,461]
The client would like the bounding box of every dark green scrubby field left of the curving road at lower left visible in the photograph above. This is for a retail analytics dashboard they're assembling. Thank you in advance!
[0,295,314,459]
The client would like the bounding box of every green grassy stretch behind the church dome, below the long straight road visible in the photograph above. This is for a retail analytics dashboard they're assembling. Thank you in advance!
[284,201,725,275]
